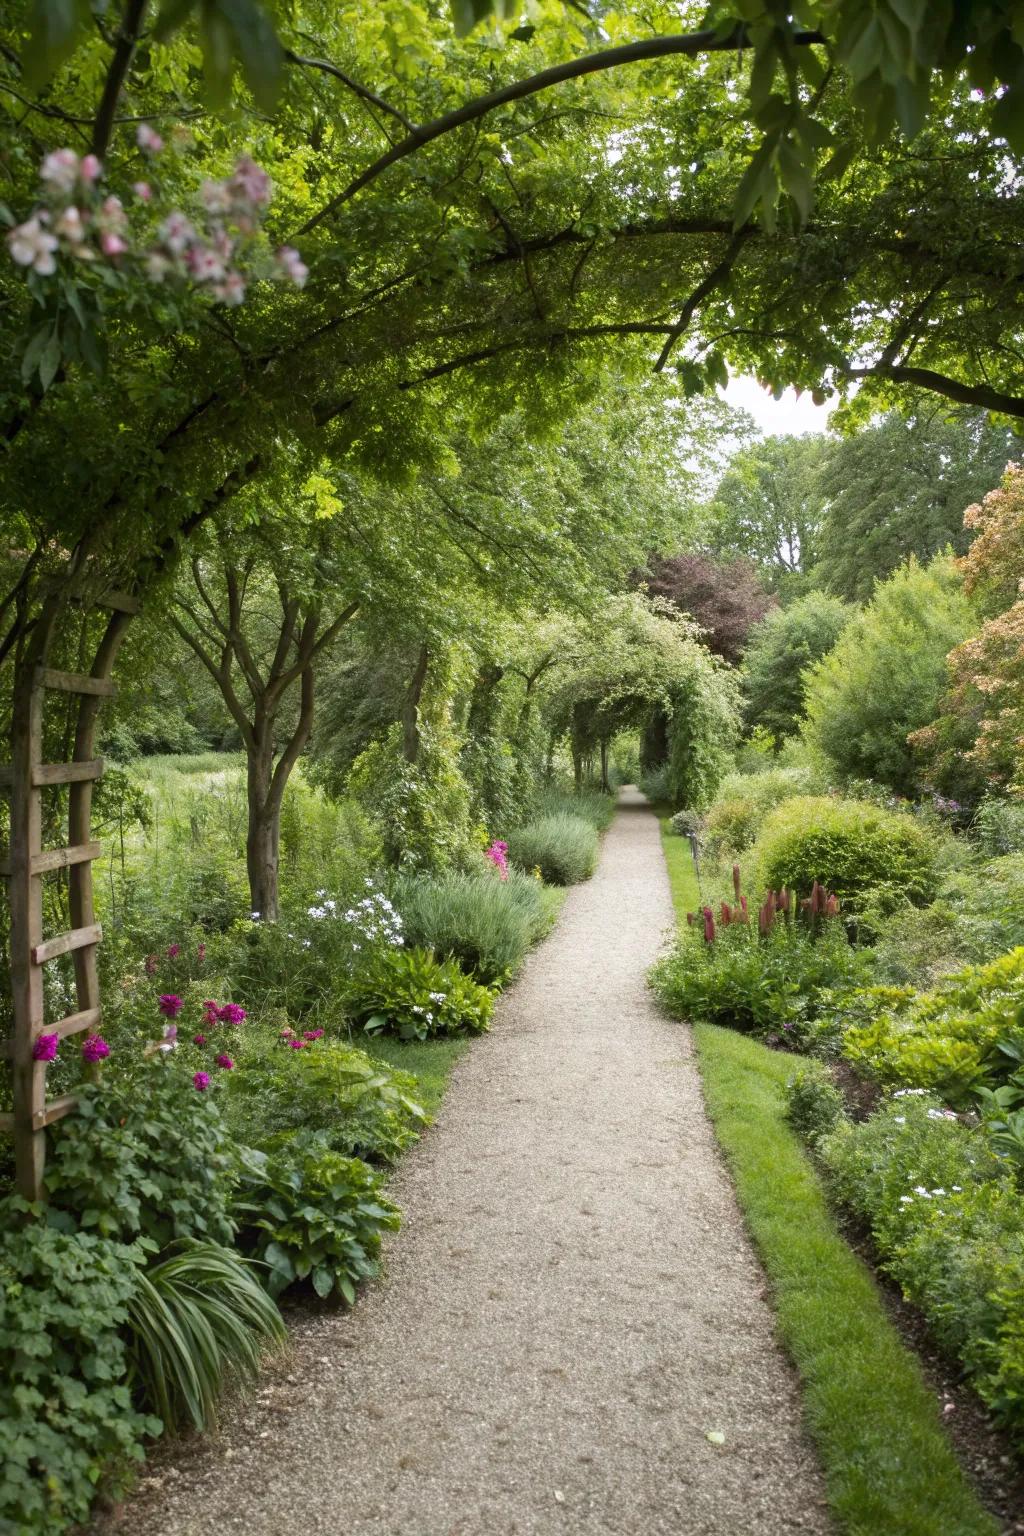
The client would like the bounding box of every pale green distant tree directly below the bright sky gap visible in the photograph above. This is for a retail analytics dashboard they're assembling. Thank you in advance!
[708,433,832,593]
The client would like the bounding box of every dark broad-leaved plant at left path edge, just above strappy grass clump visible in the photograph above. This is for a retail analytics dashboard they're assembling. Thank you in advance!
[236,1134,399,1304]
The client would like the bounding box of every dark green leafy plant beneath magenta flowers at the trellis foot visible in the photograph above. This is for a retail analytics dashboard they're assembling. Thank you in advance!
[46,1057,233,1249]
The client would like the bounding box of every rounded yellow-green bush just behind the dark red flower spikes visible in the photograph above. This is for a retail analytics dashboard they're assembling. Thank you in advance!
[754,796,935,914]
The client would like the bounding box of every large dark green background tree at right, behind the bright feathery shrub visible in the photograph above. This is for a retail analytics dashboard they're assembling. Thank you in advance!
[814,409,1013,602]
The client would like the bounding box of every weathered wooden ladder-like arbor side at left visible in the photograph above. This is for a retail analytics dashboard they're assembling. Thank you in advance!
[0,593,138,1200]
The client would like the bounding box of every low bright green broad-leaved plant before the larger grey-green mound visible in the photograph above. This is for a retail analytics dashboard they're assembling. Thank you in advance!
[348,948,494,1040]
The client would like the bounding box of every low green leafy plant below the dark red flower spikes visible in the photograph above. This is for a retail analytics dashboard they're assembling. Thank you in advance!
[651,920,867,1046]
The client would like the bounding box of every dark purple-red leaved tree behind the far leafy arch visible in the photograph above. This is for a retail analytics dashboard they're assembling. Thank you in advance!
[643,554,774,662]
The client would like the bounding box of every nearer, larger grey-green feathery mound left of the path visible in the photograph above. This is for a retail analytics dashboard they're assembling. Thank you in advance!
[393,869,547,982]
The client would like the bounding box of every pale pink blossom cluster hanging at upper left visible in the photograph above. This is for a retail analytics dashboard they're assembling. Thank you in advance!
[8,141,309,304]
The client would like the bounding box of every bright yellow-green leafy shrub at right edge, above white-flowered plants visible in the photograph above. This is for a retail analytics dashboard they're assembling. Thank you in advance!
[843,948,1024,1104]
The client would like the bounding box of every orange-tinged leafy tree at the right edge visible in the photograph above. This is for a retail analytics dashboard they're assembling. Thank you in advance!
[912,465,1024,799]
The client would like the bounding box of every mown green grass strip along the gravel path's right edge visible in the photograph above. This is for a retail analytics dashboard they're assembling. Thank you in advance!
[662,820,999,1536]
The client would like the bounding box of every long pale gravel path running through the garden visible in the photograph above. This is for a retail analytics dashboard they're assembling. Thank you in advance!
[110,791,831,1536]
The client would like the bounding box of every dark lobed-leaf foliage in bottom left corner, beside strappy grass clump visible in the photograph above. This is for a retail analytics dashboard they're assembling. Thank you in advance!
[0,1197,160,1536]
